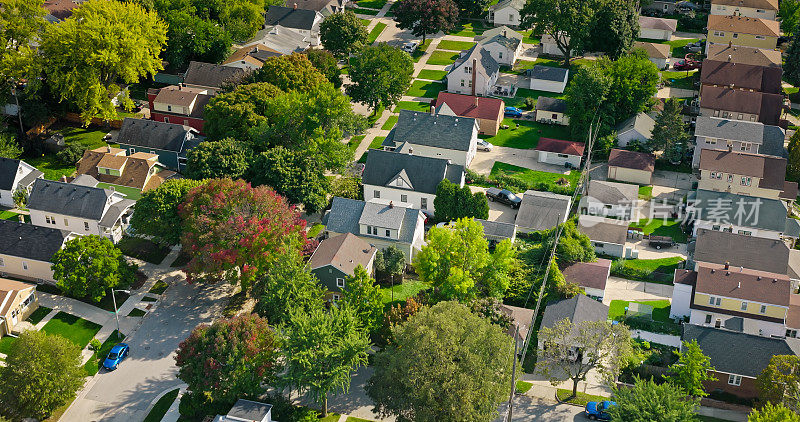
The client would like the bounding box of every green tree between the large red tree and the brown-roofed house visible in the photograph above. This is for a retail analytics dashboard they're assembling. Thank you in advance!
[252,251,325,324]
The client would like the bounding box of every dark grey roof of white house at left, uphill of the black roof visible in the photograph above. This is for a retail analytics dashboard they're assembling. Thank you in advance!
[28,179,113,220]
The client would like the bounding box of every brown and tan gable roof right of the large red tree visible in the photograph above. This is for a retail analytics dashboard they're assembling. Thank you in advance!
[309,233,377,275]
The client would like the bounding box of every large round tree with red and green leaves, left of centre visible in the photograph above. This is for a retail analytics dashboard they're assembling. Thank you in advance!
[179,179,306,289]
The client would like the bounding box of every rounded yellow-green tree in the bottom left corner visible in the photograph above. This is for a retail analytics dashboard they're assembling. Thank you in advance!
[0,330,86,420]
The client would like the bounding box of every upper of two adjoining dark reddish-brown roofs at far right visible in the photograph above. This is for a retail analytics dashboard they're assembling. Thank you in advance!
[700,60,783,94]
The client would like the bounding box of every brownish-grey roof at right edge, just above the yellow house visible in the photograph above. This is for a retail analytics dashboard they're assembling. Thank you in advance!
[693,229,789,274]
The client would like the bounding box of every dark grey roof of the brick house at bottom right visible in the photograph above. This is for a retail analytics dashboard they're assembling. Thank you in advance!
[681,324,795,378]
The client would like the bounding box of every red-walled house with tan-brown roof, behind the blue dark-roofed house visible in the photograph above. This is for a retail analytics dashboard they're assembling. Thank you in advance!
[147,85,214,135]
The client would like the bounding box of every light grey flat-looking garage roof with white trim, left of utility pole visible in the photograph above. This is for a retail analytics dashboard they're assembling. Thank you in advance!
[516,190,572,233]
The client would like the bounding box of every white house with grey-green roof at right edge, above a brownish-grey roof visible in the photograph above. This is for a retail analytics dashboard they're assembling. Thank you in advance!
[687,189,800,241]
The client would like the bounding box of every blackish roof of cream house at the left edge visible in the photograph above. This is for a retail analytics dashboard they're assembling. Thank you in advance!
[0,220,70,262]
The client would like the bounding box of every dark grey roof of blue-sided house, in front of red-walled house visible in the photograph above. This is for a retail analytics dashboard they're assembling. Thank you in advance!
[116,117,196,152]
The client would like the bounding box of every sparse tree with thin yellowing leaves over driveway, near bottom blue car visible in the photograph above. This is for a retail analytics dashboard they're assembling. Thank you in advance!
[536,318,632,397]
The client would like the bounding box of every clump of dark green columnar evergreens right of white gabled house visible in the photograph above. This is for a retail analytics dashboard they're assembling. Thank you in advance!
[433,179,489,221]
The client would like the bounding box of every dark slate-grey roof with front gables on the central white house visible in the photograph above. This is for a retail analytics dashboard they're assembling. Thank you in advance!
[361,149,464,194]
